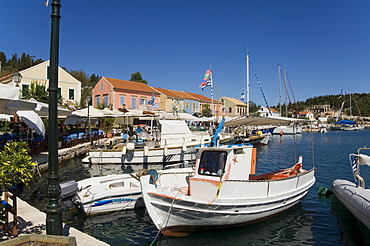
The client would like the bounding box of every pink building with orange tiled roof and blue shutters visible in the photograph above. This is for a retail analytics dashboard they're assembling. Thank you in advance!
[93,77,160,110]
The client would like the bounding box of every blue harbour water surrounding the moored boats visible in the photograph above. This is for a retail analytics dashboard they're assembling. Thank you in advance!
[24,129,370,246]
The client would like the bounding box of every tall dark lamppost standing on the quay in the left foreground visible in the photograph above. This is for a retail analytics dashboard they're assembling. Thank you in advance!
[45,0,64,235]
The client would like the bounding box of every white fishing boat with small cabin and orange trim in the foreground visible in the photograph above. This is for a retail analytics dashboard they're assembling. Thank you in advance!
[140,121,315,236]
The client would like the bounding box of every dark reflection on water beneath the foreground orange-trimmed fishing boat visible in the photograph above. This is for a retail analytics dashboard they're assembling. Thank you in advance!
[158,204,315,245]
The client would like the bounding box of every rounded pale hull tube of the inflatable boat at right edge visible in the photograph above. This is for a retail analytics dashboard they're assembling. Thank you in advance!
[331,179,370,229]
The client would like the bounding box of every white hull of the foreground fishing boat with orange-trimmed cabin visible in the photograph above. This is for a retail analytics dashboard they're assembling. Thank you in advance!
[141,169,315,234]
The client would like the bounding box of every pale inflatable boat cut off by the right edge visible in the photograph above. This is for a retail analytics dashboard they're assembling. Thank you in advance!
[331,148,370,229]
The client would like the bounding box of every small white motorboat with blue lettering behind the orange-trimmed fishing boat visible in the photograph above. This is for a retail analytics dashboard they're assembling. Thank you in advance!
[60,168,193,215]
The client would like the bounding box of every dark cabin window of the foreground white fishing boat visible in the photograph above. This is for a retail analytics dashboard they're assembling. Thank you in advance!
[198,151,227,176]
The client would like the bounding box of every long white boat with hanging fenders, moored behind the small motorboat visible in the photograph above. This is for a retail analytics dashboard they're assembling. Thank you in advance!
[83,120,211,165]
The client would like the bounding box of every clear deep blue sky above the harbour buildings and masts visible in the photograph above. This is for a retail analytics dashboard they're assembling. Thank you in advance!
[0,0,370,106]
